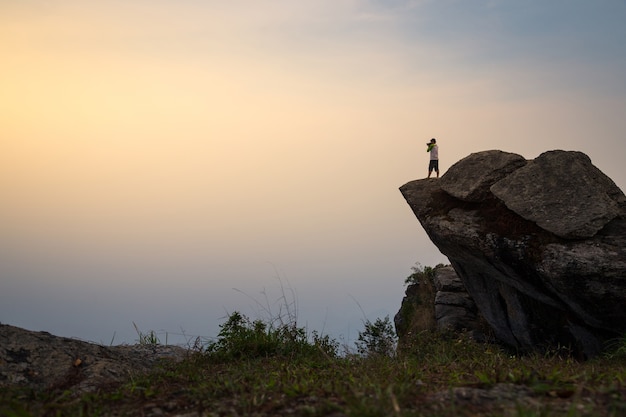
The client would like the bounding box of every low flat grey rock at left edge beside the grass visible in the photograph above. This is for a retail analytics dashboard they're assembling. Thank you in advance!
[0,324,189,393]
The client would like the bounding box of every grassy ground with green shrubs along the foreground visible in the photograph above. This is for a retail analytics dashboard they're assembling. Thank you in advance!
[0,313,626,417]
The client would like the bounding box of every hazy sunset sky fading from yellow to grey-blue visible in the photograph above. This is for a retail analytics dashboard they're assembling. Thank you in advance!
[0,0,626,344]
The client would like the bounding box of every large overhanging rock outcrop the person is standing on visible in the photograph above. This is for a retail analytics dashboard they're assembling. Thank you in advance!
[400,151,626,357]
